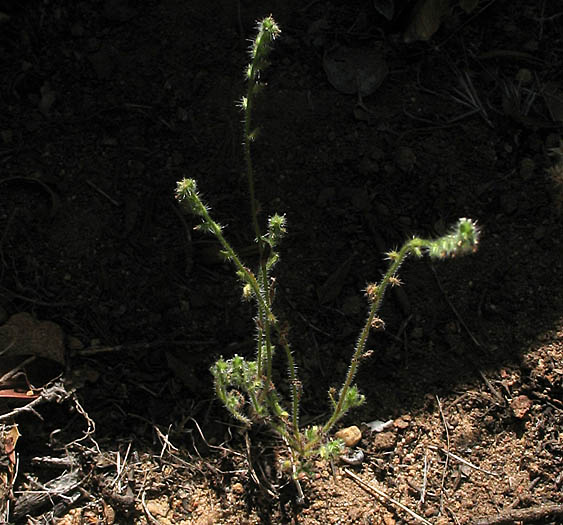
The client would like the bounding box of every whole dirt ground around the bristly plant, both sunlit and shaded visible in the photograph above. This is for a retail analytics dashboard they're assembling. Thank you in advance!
[0,0,563,525]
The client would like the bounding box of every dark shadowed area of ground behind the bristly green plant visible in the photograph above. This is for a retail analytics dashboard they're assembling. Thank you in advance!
[0,0,563,520]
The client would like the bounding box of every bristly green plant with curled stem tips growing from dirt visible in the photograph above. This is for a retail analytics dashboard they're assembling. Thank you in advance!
[176,16,479,472]
